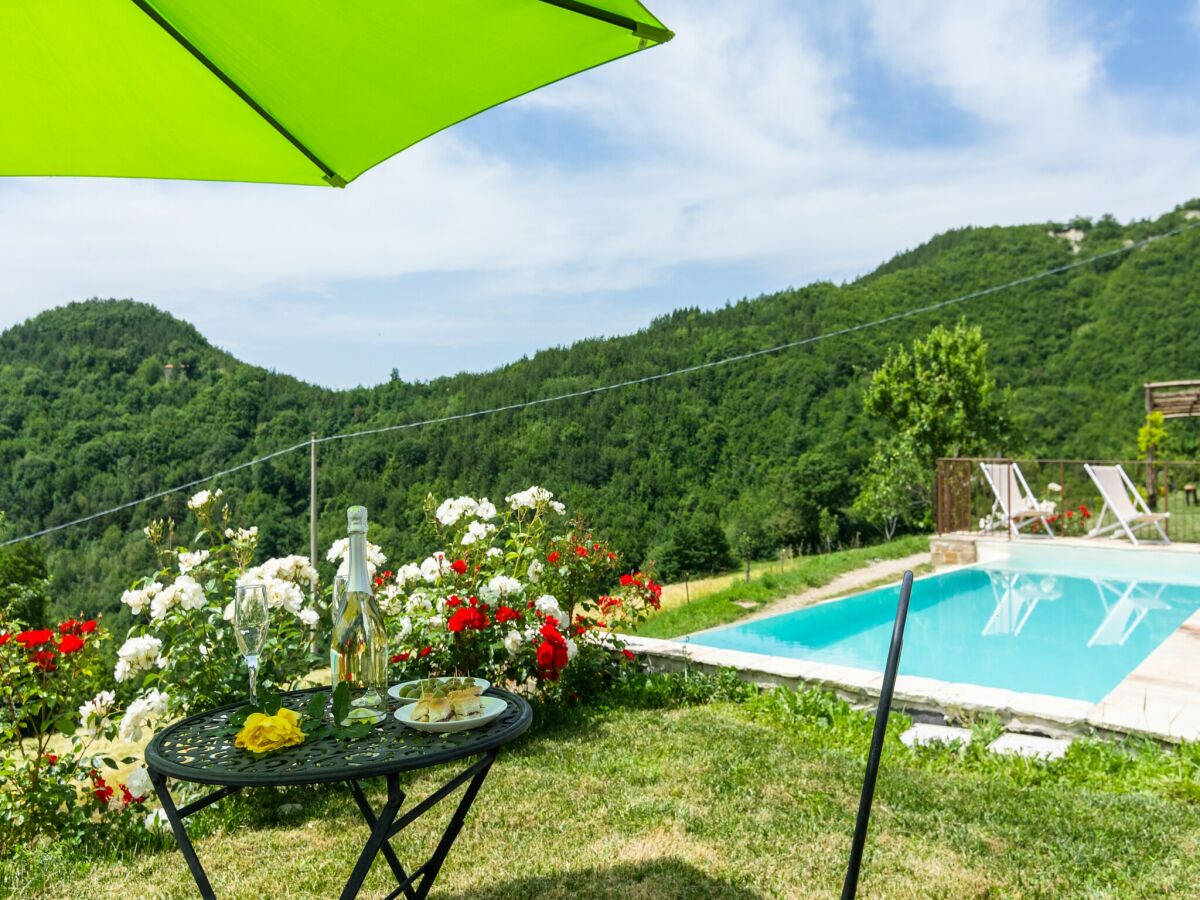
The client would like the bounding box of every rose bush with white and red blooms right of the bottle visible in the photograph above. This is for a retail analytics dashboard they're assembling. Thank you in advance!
[372,487,661,697]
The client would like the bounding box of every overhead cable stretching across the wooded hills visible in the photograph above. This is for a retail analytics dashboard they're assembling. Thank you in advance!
[0,221,1200,547]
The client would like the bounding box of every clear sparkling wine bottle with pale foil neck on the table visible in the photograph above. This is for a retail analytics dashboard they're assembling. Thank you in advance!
[329,506,388,724]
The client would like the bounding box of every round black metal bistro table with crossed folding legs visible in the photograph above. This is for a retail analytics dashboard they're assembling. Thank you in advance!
[145,688,533,900]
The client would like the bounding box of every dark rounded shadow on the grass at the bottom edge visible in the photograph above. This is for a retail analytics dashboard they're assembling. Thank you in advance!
[434,857,763,900]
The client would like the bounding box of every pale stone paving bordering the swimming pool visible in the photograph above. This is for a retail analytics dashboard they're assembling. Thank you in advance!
[628,539,1200,743]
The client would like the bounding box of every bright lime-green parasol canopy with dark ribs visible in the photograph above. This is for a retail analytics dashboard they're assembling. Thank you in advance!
[0,0,672,187]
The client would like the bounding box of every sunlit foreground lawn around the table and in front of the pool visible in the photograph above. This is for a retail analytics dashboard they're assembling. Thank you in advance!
[9,676,1200,900]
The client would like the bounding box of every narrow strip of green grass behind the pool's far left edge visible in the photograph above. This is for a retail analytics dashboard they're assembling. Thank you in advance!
[637,534,929,637]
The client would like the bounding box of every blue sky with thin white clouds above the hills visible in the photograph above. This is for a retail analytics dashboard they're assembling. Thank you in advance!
[0,0,1200,386]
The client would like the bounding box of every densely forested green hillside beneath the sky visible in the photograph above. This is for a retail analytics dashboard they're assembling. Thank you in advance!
[0,202,1200,612]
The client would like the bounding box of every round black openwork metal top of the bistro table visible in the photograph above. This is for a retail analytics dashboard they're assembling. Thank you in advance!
[145,688,533,786]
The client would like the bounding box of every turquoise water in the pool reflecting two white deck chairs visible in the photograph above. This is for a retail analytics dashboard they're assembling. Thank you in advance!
[689,566,1200,702]
